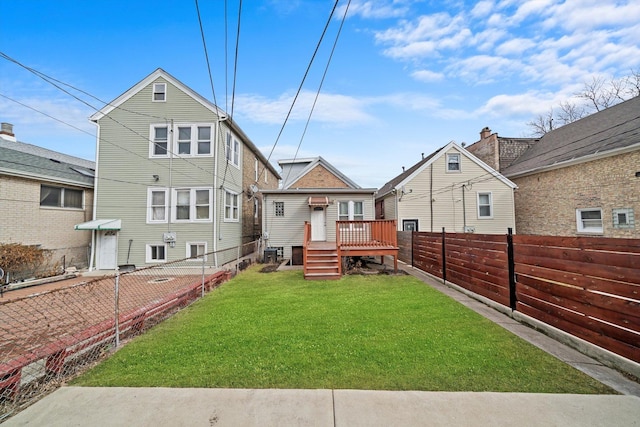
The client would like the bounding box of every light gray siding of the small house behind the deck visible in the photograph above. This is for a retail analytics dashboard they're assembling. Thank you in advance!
[262,192,375,259]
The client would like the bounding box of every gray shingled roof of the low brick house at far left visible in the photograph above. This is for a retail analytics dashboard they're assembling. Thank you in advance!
[0,138,95,188]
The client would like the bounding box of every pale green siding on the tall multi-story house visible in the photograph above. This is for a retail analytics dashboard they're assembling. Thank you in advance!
[96,78,244,265]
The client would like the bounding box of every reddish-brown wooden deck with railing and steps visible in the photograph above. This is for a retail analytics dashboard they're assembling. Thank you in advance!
[303,220,398,280]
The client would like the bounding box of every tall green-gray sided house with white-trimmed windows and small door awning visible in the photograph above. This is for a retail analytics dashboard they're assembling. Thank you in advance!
[76,69,277,270]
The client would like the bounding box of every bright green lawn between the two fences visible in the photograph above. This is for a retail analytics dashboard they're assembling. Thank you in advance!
[74,267,614,393]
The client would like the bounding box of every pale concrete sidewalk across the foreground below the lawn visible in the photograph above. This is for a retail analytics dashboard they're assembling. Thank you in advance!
[5,387,640,427]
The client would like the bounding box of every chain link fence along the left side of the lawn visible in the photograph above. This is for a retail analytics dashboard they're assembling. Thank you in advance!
[0,242,258,423]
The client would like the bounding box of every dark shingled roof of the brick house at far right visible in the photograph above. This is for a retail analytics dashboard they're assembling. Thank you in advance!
[503,97,640,177]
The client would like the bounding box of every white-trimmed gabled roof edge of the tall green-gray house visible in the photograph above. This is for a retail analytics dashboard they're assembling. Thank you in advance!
[89,68,280,179]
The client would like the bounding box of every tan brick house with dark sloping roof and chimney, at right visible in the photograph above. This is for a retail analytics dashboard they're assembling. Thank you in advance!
[467,97,640,238]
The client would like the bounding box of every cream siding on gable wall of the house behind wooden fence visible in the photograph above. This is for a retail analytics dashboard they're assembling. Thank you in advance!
[396,149,515,234]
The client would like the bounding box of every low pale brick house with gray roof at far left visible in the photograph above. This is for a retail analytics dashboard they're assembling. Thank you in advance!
[0,123,95,268]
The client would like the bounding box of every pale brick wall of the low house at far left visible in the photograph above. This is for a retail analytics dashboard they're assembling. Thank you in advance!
[0,175,93,267]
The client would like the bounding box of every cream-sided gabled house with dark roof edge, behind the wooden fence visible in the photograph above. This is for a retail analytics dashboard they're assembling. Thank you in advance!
[376,142,516,234]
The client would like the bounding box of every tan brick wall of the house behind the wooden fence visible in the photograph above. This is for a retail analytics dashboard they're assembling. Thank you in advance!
[512,151,640,238]
